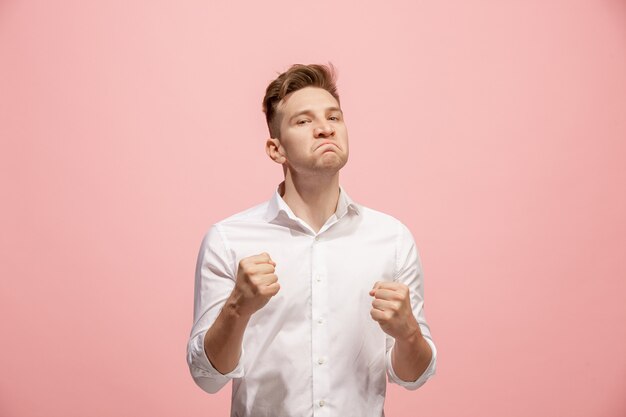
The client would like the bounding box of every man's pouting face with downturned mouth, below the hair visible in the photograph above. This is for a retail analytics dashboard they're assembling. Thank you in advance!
[273,87,348,175]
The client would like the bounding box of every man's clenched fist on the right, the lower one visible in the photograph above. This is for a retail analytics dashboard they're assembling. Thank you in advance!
[370,281,421,340]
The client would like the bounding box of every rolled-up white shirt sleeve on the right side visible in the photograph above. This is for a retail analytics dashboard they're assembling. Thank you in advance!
[385,223,437,390]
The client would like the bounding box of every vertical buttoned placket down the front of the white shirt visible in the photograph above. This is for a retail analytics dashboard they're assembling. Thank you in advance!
[311,234,332,416]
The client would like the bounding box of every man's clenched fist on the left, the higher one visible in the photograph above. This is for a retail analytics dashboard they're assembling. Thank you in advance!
[231,252,280,316]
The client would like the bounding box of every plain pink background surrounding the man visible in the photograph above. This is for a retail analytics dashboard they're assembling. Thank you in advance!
[0,0,626,417]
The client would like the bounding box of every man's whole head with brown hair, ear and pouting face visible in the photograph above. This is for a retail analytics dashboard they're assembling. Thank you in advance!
[263,65,348,175]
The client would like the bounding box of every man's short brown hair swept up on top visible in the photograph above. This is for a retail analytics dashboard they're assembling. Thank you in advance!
[263,62,339,138]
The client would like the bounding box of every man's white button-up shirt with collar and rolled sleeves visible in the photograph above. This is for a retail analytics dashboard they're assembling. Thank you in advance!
[187,187,437,417]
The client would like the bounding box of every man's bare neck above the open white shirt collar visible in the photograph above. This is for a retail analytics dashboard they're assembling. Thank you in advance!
[280,170,339,233]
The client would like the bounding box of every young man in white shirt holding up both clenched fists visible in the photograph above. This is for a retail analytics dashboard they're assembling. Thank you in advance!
[187,65,437,417]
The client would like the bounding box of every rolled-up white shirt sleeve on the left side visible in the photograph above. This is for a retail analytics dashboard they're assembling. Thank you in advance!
[187,225,244,393]
